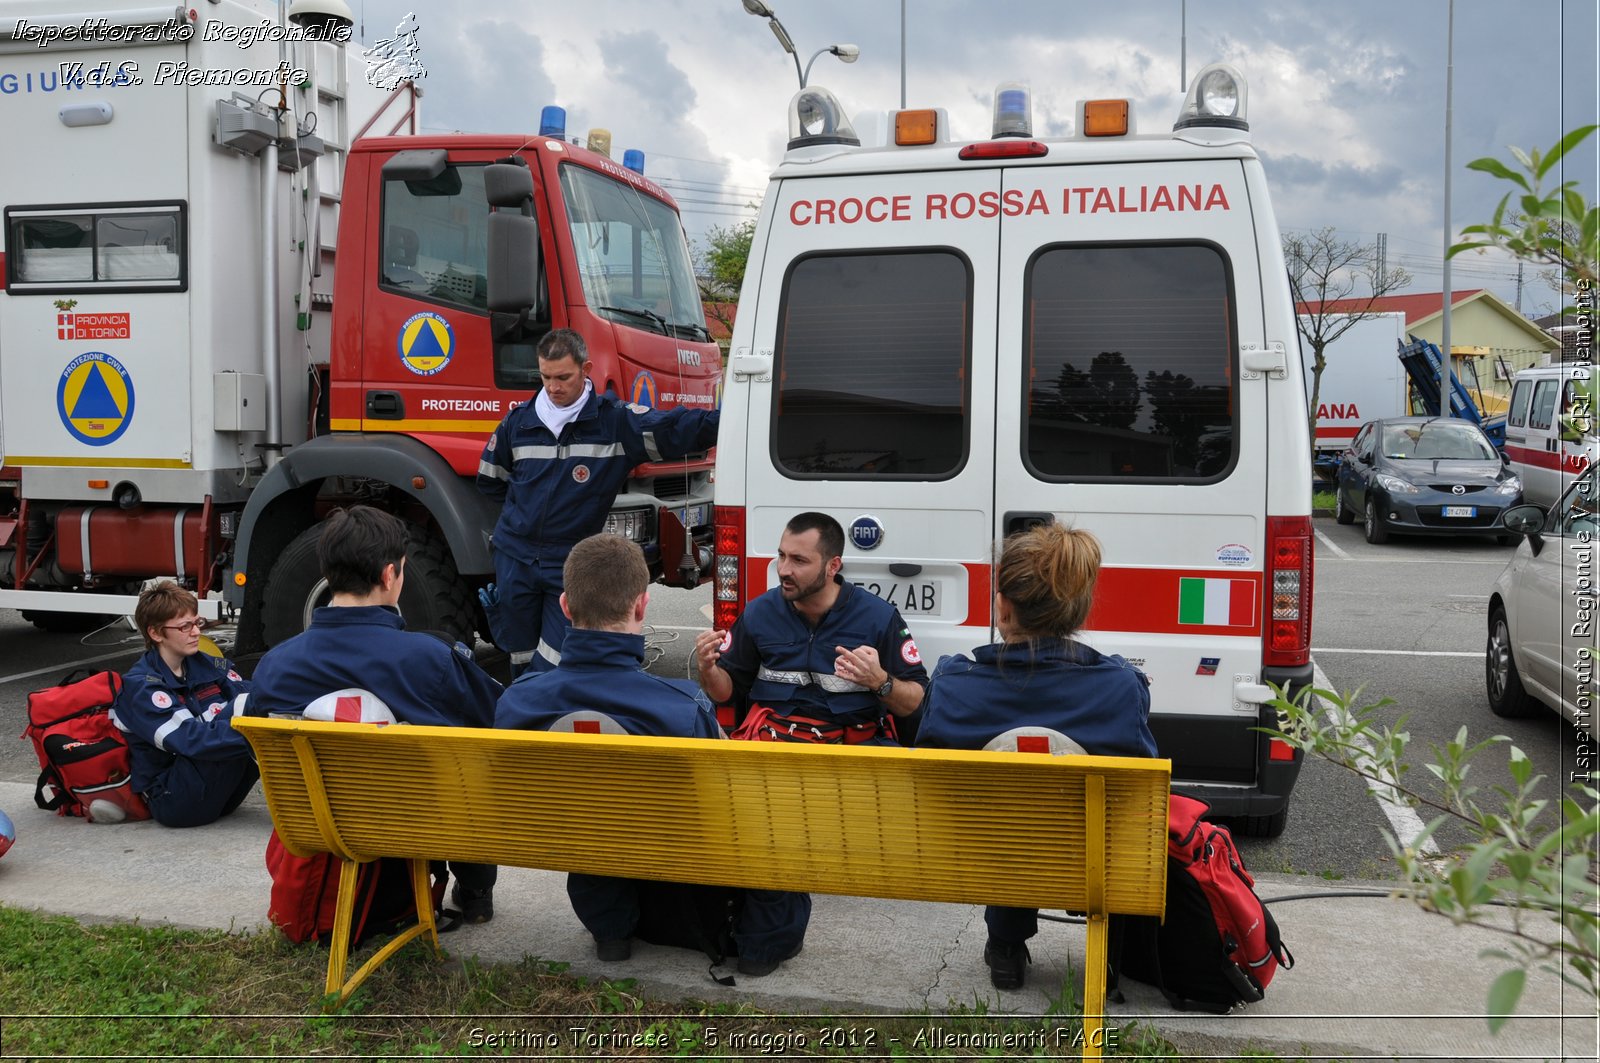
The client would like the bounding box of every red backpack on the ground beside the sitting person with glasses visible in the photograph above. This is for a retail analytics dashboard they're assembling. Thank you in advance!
[22,669,150,823]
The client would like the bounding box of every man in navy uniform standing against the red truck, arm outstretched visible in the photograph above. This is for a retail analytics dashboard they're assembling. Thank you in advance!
[478,328,718,674]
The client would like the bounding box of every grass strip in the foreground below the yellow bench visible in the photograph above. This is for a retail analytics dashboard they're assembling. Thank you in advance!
[0,906,1324,1060]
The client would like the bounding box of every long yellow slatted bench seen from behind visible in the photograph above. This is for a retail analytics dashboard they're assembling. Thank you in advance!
[234,717,1171,1055]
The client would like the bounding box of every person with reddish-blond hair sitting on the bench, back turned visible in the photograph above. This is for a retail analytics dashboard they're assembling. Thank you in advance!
[917,523,1155,989]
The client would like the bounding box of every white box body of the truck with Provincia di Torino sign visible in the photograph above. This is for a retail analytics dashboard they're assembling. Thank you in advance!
[0,0,400,616]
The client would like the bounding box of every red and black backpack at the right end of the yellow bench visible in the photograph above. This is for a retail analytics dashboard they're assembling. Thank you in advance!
[1117,794,1294,1015]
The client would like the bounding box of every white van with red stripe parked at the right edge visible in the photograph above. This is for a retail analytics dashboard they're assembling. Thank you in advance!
[1506,363,1595,507]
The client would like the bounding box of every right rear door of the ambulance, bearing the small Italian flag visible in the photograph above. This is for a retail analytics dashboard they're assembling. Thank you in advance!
[994,158,1267,786]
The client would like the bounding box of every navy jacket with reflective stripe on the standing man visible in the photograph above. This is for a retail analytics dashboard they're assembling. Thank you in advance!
[478,385,720,562]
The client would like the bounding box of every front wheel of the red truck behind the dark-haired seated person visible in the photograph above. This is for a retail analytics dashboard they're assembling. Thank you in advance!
[261,523,474,645]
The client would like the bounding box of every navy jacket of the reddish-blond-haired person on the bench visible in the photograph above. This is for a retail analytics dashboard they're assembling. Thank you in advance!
[917,639,1155,757]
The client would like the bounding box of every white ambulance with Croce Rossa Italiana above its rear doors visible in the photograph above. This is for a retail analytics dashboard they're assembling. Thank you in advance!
[715,66,1312,836]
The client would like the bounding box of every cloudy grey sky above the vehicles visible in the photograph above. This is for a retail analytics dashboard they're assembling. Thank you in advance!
[349,0,1600,314]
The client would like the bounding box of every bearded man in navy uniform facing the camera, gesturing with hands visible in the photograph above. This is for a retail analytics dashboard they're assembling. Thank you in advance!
[694,512,928,977]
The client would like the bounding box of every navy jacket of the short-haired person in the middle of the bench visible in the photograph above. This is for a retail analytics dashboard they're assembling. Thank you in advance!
[494,628,722,738]
